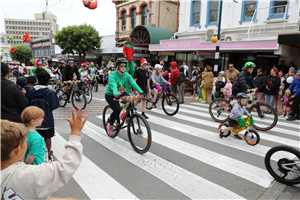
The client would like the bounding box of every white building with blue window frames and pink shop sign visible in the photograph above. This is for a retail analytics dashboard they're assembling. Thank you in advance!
[149,0,300,71]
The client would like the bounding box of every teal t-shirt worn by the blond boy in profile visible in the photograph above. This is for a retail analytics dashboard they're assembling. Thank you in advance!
[25,131,48,165]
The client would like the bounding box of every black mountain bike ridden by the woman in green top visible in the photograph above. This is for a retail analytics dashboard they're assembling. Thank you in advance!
[102,96,152,154]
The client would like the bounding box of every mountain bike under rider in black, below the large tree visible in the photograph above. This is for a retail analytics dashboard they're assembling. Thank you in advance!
[56,80,87,110]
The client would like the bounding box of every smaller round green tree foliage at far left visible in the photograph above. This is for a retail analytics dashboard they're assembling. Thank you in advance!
[10,44,32,64]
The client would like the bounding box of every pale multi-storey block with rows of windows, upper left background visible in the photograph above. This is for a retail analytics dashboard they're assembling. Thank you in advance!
[4,12,59,46]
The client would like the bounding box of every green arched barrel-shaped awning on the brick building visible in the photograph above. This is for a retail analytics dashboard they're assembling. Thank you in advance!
[130,25,173,46]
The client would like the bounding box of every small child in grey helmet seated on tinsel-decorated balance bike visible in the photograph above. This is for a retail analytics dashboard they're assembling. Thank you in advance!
[220,93,251,140]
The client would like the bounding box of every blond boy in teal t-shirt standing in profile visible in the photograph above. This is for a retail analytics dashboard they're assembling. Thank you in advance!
[21,106,49,165]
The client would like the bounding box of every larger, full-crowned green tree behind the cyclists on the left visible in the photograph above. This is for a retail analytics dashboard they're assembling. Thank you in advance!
[55,24,101,63]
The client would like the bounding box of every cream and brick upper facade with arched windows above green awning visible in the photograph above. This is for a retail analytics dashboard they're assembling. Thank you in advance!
[112,0,179,47]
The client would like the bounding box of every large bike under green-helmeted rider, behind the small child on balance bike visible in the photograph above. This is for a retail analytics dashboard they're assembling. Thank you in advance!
[209,89,278,131]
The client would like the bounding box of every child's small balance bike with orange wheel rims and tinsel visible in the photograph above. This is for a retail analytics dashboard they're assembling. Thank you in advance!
[218,116,260,146]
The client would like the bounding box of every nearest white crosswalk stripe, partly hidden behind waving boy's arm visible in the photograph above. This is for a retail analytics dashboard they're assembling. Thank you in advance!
[52,132,137,199]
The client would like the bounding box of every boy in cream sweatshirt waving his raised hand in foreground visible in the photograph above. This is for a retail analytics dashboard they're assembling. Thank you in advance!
[0,108,87,199]
